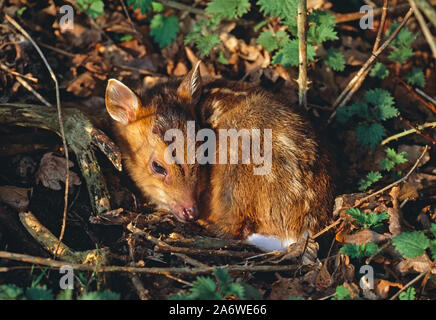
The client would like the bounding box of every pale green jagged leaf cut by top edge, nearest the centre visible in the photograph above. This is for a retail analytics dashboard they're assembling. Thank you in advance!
[206,0,250,20]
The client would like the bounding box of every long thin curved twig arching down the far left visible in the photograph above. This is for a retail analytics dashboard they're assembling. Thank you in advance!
[5,14,70,255]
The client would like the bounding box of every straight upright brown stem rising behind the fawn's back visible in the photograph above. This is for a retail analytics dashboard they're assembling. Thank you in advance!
[297,0,307,110]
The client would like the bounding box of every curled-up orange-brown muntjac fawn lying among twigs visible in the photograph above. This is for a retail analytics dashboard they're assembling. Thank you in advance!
[106,64,333,251]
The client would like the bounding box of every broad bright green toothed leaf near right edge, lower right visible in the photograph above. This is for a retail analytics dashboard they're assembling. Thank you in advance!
[392,231,430,258]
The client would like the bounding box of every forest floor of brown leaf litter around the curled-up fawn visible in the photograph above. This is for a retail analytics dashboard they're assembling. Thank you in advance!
[0,0,436,299]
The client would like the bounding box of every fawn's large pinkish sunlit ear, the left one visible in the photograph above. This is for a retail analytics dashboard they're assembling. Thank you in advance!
[105,79,141,124]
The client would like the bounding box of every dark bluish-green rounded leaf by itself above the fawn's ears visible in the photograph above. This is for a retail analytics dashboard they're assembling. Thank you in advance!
[150,13,179,48]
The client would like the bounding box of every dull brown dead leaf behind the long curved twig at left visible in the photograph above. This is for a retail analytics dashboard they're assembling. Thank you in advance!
[36,152,81,190]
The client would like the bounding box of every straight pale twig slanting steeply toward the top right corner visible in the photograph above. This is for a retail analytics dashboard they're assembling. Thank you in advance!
[328,8,413,123]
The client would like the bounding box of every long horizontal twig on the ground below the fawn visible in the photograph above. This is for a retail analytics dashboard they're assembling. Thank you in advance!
[0,251,296,275]
